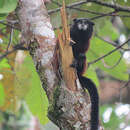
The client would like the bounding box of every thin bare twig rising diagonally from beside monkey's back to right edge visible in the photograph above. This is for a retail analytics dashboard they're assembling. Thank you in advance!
[88,38,130,66]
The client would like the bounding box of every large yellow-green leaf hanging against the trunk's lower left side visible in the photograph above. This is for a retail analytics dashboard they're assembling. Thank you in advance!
[15,56,49,124]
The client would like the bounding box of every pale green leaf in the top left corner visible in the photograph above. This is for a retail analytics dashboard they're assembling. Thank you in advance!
[0,0,17,14]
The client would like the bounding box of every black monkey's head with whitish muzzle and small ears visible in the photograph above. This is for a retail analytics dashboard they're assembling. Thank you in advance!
[73,18,94,31]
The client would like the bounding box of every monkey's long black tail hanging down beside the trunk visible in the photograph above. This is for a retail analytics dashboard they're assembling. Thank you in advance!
[78,74,99,130]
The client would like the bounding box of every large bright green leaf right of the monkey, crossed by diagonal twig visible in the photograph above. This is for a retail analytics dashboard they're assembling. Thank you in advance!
[87,37,128,81]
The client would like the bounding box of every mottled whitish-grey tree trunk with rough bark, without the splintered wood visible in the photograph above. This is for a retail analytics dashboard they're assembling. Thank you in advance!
[18,0,101,130]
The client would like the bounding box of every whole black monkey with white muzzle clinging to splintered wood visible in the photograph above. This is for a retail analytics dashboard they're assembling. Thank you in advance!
[70,18,99,130]
